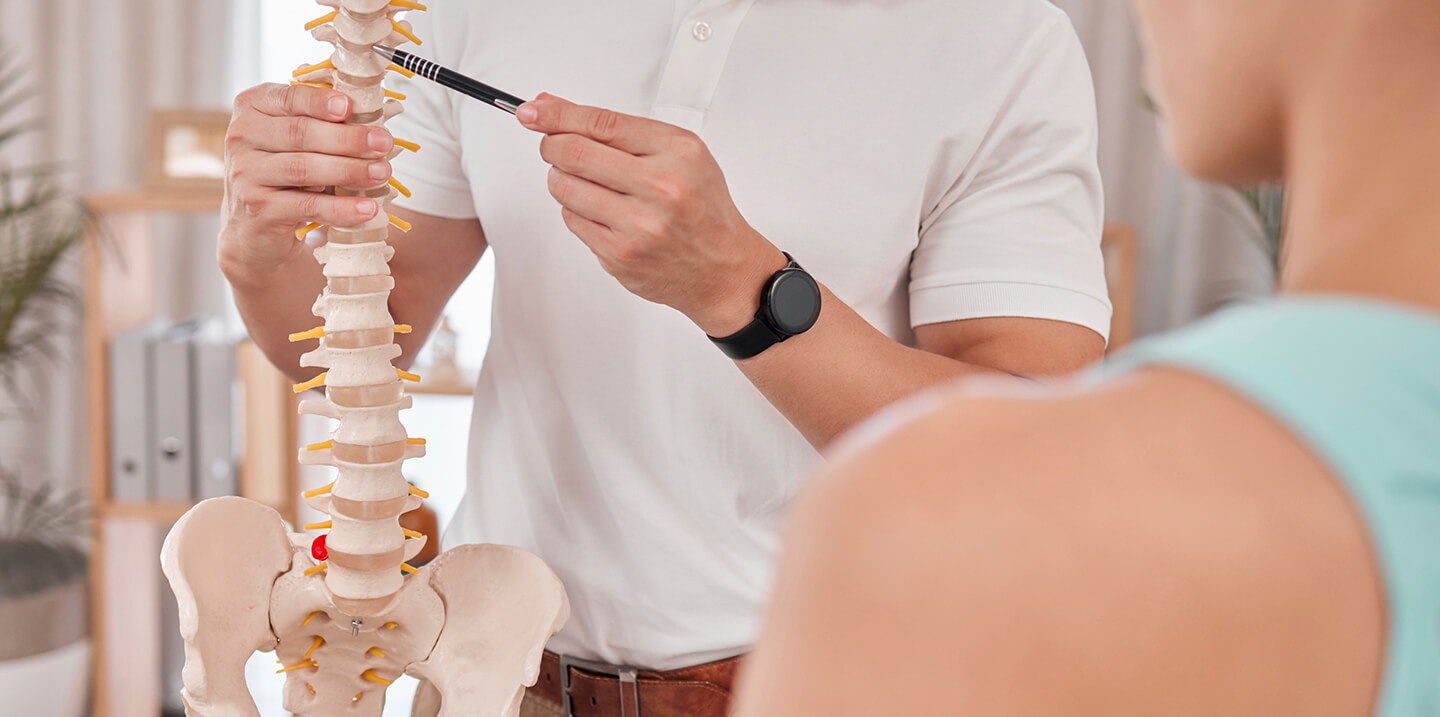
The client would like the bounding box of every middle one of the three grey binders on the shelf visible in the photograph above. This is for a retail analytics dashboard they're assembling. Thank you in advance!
[150,323,196,502]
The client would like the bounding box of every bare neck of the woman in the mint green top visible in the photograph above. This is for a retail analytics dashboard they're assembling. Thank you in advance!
[1280,17,1440,311]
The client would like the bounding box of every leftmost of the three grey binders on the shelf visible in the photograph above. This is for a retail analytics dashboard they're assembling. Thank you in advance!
[109,325,157,502]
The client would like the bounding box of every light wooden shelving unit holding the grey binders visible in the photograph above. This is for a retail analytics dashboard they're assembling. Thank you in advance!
[84,191,298,717]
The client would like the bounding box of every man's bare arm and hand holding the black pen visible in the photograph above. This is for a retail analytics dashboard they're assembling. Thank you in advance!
[517,95,1104,446]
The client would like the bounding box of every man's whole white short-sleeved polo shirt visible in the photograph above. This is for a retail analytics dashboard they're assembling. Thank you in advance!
[392,0,1110,669]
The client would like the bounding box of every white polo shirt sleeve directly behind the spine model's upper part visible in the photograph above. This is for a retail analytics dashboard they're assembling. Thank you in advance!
[387,9,478,219]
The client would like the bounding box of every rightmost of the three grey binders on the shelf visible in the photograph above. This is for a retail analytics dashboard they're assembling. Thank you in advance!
[193,323,240,501]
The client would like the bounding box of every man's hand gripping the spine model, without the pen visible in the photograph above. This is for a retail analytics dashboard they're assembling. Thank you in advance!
[217,85,395,282]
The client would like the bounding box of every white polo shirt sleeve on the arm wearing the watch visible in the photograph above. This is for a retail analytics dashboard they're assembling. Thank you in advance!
[910,12,1110,337]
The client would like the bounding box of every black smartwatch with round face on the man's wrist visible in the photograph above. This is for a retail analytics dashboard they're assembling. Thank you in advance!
[710,253,819,361]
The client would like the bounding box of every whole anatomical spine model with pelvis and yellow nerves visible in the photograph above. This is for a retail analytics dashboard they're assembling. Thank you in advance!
[161,0,569,717]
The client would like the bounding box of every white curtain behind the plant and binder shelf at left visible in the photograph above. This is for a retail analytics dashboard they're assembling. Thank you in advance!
[0,0,243,487]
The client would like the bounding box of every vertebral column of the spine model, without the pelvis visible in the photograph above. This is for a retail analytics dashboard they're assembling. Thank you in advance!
[291,0,426,616]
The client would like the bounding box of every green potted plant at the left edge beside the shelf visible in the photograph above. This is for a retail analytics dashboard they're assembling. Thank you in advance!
[0,51,89,717]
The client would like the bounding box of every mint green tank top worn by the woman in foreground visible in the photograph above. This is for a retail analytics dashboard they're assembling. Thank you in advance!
[1102,297,1440,717]
